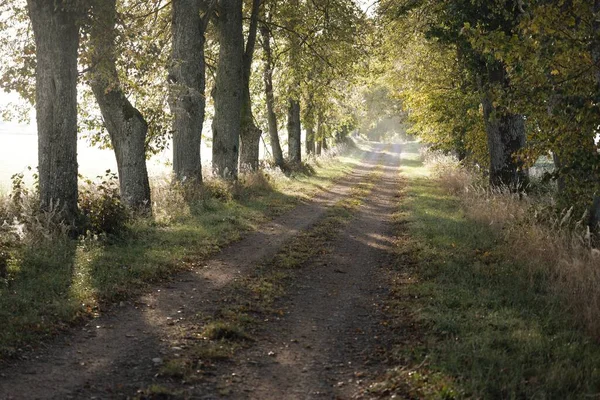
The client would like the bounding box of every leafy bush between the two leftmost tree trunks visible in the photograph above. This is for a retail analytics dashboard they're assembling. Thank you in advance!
[79,170,131,235]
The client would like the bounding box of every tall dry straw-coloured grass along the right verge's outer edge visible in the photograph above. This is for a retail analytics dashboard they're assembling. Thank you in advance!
[424,152,600,337]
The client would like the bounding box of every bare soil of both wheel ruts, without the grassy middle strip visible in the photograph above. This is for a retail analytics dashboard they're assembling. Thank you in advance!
[0,144,400,399]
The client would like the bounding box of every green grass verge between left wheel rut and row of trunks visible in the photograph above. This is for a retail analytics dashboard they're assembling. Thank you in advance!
[0,147,362,359]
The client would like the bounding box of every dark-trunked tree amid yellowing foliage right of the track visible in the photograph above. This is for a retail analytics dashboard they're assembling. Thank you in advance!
[382,0,527,189]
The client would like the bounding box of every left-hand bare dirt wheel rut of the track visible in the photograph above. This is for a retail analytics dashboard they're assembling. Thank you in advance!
[0,145,382,399]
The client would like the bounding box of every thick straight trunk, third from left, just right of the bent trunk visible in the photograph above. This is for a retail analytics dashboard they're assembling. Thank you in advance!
[169,0,211,183]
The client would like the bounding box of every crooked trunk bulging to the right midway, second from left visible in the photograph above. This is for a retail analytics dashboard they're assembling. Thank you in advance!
[90,0,152,213]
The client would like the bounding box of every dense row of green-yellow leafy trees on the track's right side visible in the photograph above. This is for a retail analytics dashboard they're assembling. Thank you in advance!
[378,0,600,227]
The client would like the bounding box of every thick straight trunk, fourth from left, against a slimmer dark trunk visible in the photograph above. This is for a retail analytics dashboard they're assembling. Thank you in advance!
[212,0,244,179]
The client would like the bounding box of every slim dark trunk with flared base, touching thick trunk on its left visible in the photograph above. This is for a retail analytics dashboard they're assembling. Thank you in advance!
[240,0,262,171]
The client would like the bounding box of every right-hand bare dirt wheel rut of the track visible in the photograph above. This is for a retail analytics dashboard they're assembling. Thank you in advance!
[206,145,400,400]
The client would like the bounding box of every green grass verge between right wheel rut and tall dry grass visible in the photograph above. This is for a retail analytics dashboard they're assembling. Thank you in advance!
[373,144,600,399]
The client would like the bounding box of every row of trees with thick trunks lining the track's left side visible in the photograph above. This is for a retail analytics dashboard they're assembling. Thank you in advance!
[0,0,366,221]
